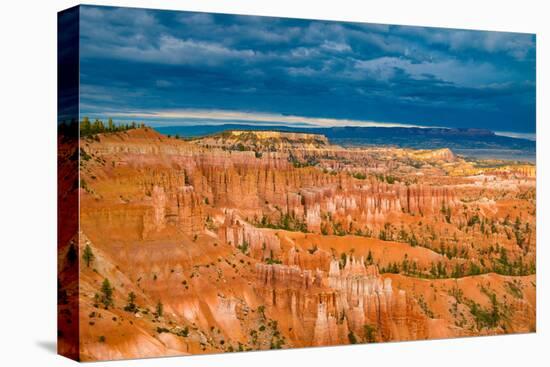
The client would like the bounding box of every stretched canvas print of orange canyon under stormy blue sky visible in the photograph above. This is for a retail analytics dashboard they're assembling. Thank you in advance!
[58,6,536,361]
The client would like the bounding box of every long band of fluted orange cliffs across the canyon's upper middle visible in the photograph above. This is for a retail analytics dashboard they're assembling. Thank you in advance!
[83,129,457,236]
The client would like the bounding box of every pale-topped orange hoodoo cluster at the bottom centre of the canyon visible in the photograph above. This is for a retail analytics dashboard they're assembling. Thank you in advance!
[252,257,434,345]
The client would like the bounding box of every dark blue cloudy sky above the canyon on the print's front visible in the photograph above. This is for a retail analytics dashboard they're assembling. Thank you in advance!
[80,6,536,136]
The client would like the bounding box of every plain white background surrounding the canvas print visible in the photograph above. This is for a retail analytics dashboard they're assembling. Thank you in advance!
[0,0,550,367]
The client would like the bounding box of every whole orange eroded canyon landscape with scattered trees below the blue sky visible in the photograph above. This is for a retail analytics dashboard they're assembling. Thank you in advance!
[72,128,536,360]
